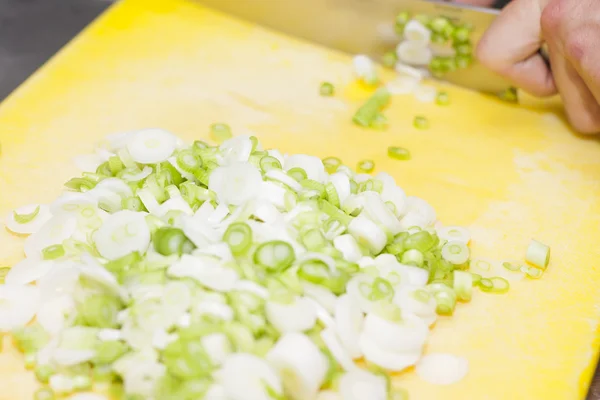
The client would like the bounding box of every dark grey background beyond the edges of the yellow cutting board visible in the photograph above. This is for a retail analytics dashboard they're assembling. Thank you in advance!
[0,0,600,400]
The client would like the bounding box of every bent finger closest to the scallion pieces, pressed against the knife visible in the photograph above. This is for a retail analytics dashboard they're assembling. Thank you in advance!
[477,0,556,96]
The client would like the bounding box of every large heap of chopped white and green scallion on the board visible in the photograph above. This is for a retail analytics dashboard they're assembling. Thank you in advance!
[0,129,549,400]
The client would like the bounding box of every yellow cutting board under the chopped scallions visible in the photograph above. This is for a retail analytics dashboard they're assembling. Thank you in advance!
[0,0,600,400]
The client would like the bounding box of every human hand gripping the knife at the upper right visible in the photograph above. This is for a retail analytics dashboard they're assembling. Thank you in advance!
[477,0,600,133]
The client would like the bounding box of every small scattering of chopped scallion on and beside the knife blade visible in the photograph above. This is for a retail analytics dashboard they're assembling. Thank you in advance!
[340,12,476,129]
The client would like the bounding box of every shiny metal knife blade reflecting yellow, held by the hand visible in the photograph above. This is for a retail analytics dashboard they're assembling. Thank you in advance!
[199,0,510,94]
